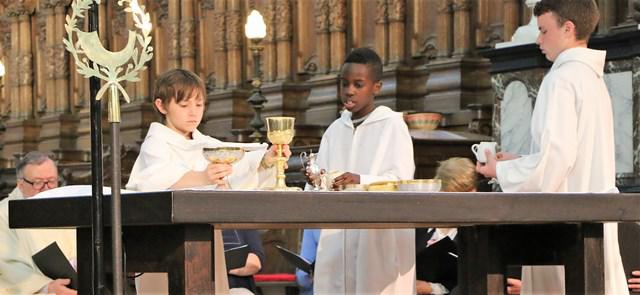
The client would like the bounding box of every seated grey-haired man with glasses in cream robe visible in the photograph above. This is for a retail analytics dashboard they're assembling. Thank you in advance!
[0,151,77,295]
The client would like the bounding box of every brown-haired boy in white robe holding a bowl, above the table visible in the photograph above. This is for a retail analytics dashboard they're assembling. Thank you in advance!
[126,69,282,191]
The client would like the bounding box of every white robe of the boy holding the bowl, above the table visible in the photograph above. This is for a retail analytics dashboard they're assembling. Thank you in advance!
[126,122,276,191]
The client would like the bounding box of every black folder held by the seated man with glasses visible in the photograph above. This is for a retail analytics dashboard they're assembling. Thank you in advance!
[32,242,78,290]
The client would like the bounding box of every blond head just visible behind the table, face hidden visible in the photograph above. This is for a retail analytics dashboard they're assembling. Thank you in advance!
[435,158,476,192]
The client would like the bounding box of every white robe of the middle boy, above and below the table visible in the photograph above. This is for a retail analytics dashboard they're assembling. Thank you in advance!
[314,106,416,295]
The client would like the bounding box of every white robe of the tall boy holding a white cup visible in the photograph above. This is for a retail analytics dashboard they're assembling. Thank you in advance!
[497,48,629,295]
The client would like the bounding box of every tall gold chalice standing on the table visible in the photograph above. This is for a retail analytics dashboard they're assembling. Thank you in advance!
[267,117,301,191]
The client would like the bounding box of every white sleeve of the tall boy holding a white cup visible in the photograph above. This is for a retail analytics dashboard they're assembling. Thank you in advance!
[496,78,578,192]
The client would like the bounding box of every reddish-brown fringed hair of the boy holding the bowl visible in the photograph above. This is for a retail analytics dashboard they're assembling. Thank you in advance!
[153,69,207,115]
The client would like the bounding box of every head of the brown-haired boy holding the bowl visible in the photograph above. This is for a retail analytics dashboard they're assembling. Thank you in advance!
[153,69,206,138]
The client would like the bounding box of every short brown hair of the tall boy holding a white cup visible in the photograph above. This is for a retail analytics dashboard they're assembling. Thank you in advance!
[533,0,600,40]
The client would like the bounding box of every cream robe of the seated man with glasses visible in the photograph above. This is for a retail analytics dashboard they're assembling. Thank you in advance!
[0,188,77,294]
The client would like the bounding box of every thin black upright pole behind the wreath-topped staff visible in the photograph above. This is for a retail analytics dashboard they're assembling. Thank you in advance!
[88,2,104,295]
